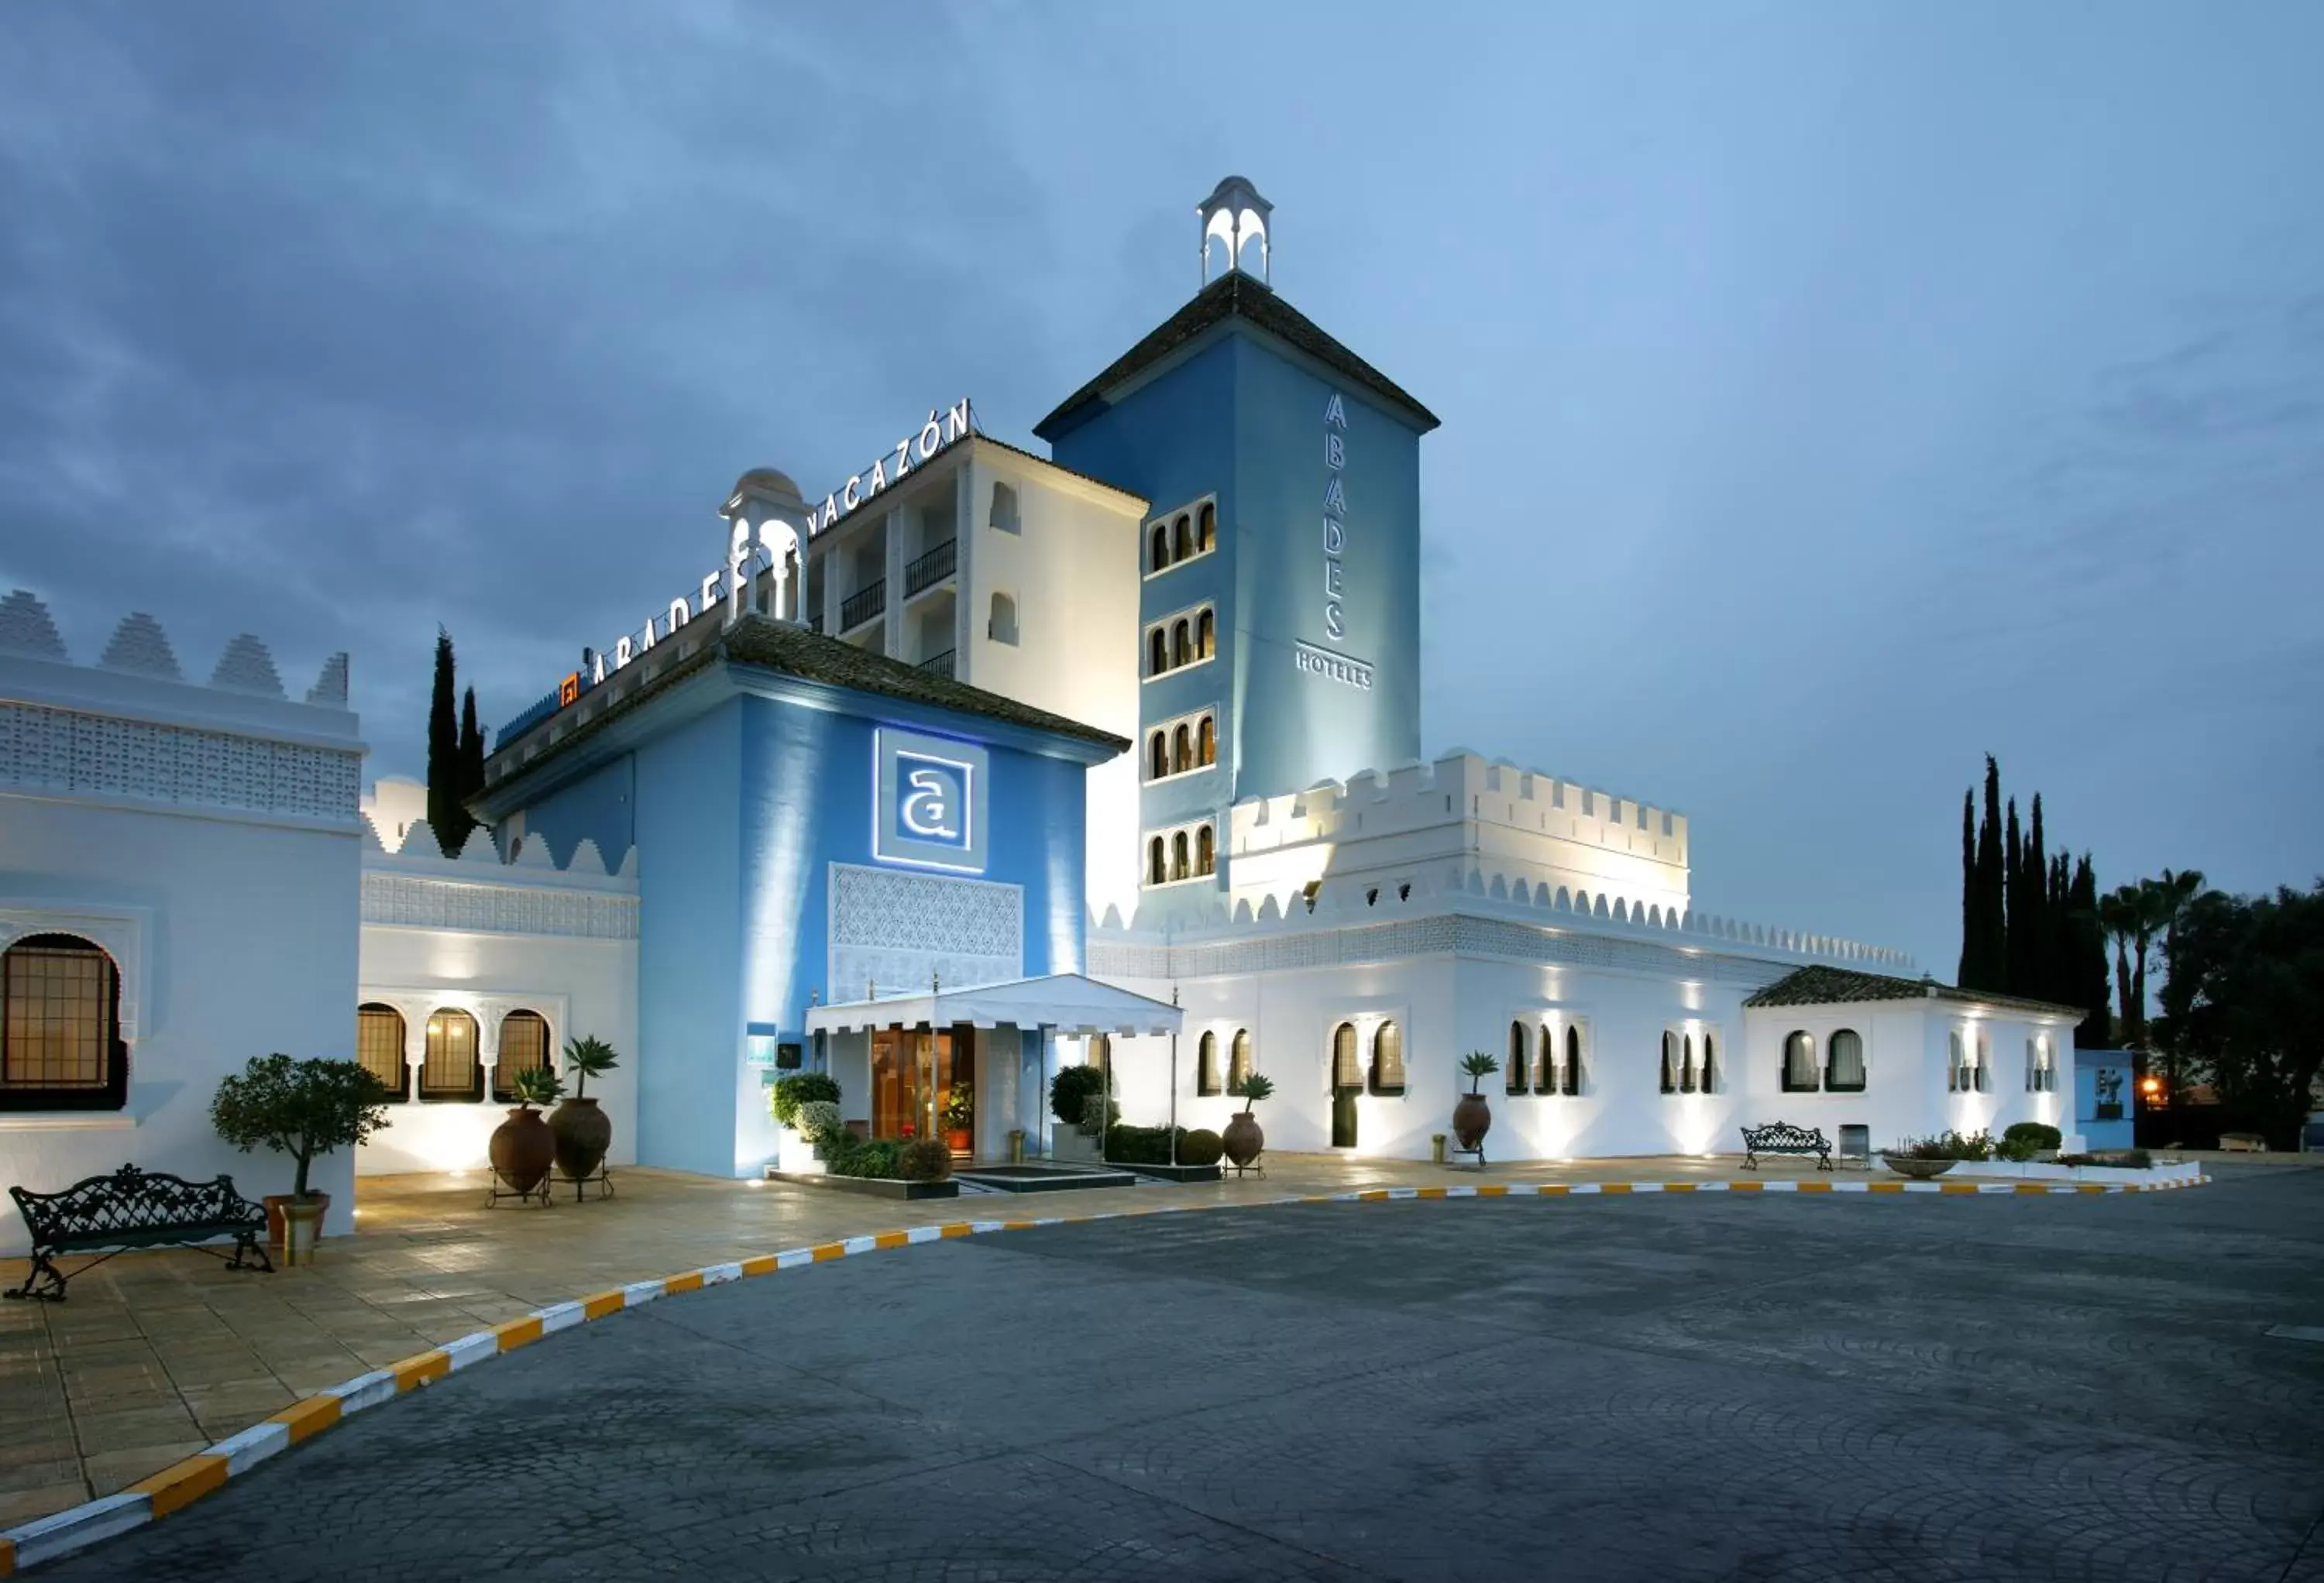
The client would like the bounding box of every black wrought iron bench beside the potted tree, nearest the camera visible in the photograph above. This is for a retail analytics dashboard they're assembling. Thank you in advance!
[7,1165,274,1302]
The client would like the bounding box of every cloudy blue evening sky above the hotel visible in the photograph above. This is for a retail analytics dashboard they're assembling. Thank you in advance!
[0,0,2324,977]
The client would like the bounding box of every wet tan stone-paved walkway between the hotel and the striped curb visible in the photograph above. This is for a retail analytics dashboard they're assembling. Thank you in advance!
[0,1155,2240,1530]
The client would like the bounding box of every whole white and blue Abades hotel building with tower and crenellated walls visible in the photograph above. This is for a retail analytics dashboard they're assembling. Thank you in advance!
[0,179,2080,1251]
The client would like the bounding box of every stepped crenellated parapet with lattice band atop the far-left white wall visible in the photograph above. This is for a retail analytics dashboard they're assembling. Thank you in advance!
[0,588,363,830]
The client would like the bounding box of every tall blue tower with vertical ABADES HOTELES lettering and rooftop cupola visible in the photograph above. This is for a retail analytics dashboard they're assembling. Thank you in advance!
[1034,177,1436,895]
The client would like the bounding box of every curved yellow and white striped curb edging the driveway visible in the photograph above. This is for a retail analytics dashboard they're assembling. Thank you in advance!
[0,1176,2210,1578]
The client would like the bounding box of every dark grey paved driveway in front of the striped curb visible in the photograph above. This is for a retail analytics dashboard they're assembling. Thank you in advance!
[27,1167,2324,1583]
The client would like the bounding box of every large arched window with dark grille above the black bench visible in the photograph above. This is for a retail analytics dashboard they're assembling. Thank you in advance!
[0,935,130,1111]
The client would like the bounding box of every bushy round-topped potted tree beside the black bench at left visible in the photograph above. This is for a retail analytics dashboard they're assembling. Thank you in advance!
[209,1053,388,1265]
